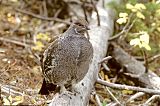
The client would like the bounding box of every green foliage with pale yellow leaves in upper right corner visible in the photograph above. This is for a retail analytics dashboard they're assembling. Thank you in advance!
[112,0,160,54]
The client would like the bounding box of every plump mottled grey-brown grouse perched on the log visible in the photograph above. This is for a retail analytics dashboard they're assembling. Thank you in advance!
[39,19,93,95]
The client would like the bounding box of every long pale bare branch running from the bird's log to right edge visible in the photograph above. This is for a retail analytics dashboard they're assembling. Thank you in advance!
[97,78,160,95]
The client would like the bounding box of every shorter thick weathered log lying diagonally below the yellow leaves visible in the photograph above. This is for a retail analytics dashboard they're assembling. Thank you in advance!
[113,46,160,90]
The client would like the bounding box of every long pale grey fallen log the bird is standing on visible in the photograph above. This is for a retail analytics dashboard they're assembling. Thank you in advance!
[49,0,117,106]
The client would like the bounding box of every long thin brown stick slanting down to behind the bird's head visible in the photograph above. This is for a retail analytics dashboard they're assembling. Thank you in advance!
[15,8,71,25]
